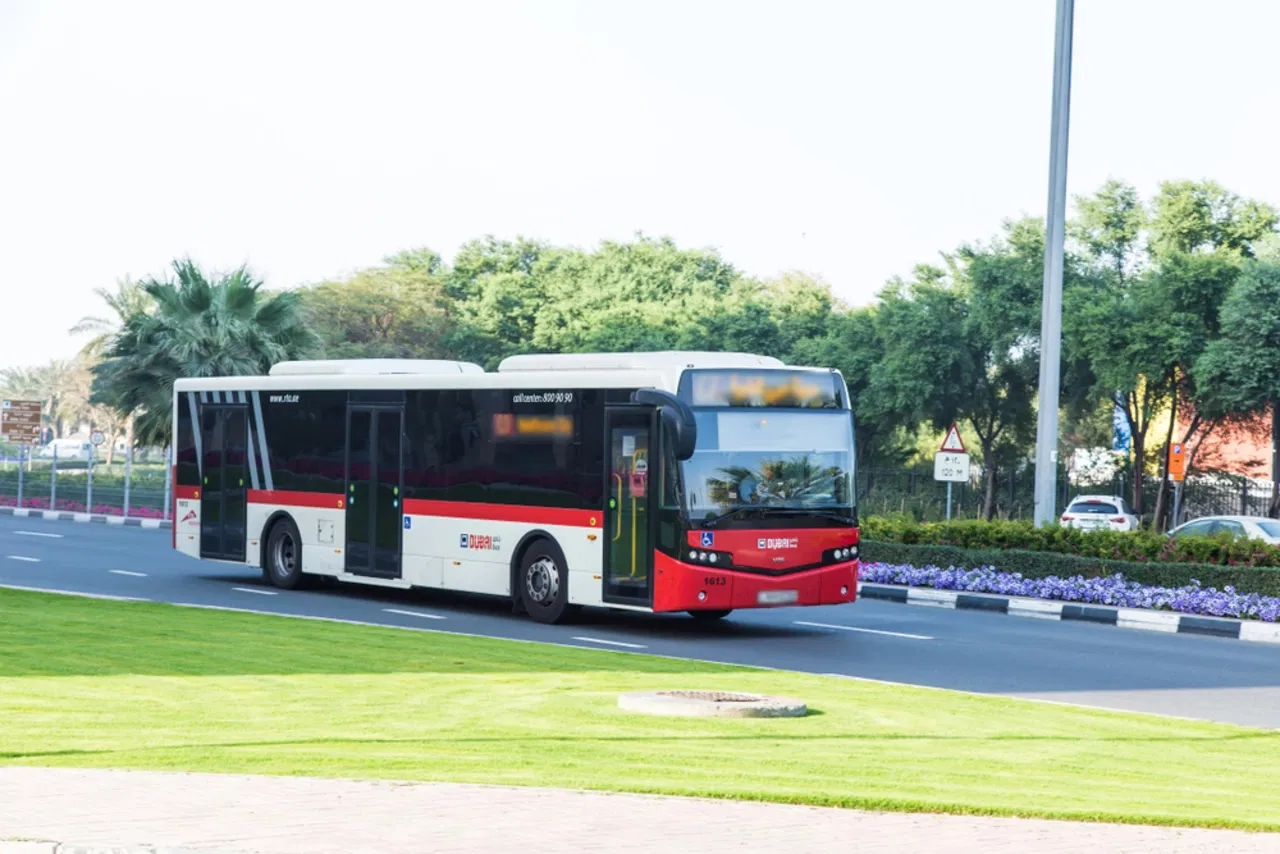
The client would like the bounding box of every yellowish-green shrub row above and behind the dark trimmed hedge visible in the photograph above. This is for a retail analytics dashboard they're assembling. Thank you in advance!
[860,516,1280,567]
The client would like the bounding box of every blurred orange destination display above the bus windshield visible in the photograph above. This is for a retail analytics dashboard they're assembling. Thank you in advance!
[680,370,844,410]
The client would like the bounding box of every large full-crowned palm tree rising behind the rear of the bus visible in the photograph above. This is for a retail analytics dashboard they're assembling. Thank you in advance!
[93,259,319,446]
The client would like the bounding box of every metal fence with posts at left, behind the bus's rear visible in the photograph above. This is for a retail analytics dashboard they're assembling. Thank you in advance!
[0,446,173,520]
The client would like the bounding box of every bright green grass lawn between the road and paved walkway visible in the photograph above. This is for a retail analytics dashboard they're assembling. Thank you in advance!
[0,589,1280,830]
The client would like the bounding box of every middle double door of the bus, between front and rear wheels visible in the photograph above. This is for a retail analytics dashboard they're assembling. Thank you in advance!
[346,406,404,579]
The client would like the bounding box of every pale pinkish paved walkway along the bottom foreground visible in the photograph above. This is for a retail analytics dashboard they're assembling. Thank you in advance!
[0,768,1280,854]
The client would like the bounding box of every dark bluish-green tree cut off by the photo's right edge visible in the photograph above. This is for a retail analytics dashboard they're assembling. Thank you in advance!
[1196,261,1280,516]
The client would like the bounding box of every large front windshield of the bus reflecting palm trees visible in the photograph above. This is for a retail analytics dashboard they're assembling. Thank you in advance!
[681,410,854,524]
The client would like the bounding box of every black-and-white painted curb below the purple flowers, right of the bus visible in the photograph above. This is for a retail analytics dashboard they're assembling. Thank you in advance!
[858,581,1280,644]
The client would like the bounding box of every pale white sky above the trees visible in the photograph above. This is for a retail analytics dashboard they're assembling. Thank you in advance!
[0,0,1280,367]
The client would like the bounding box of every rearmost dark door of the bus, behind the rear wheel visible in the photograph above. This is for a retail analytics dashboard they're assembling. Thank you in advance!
[200,403,248,561]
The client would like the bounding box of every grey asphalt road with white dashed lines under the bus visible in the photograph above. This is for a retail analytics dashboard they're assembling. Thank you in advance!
[0,516,1280,729]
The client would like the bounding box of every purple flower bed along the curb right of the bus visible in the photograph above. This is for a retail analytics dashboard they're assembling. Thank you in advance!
[859,563,1280,622]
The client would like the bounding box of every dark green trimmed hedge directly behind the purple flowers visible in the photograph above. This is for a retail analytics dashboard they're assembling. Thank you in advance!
[861,539,1280,595]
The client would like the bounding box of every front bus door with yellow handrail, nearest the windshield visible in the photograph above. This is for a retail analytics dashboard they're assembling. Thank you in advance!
[603,406,657,604]
